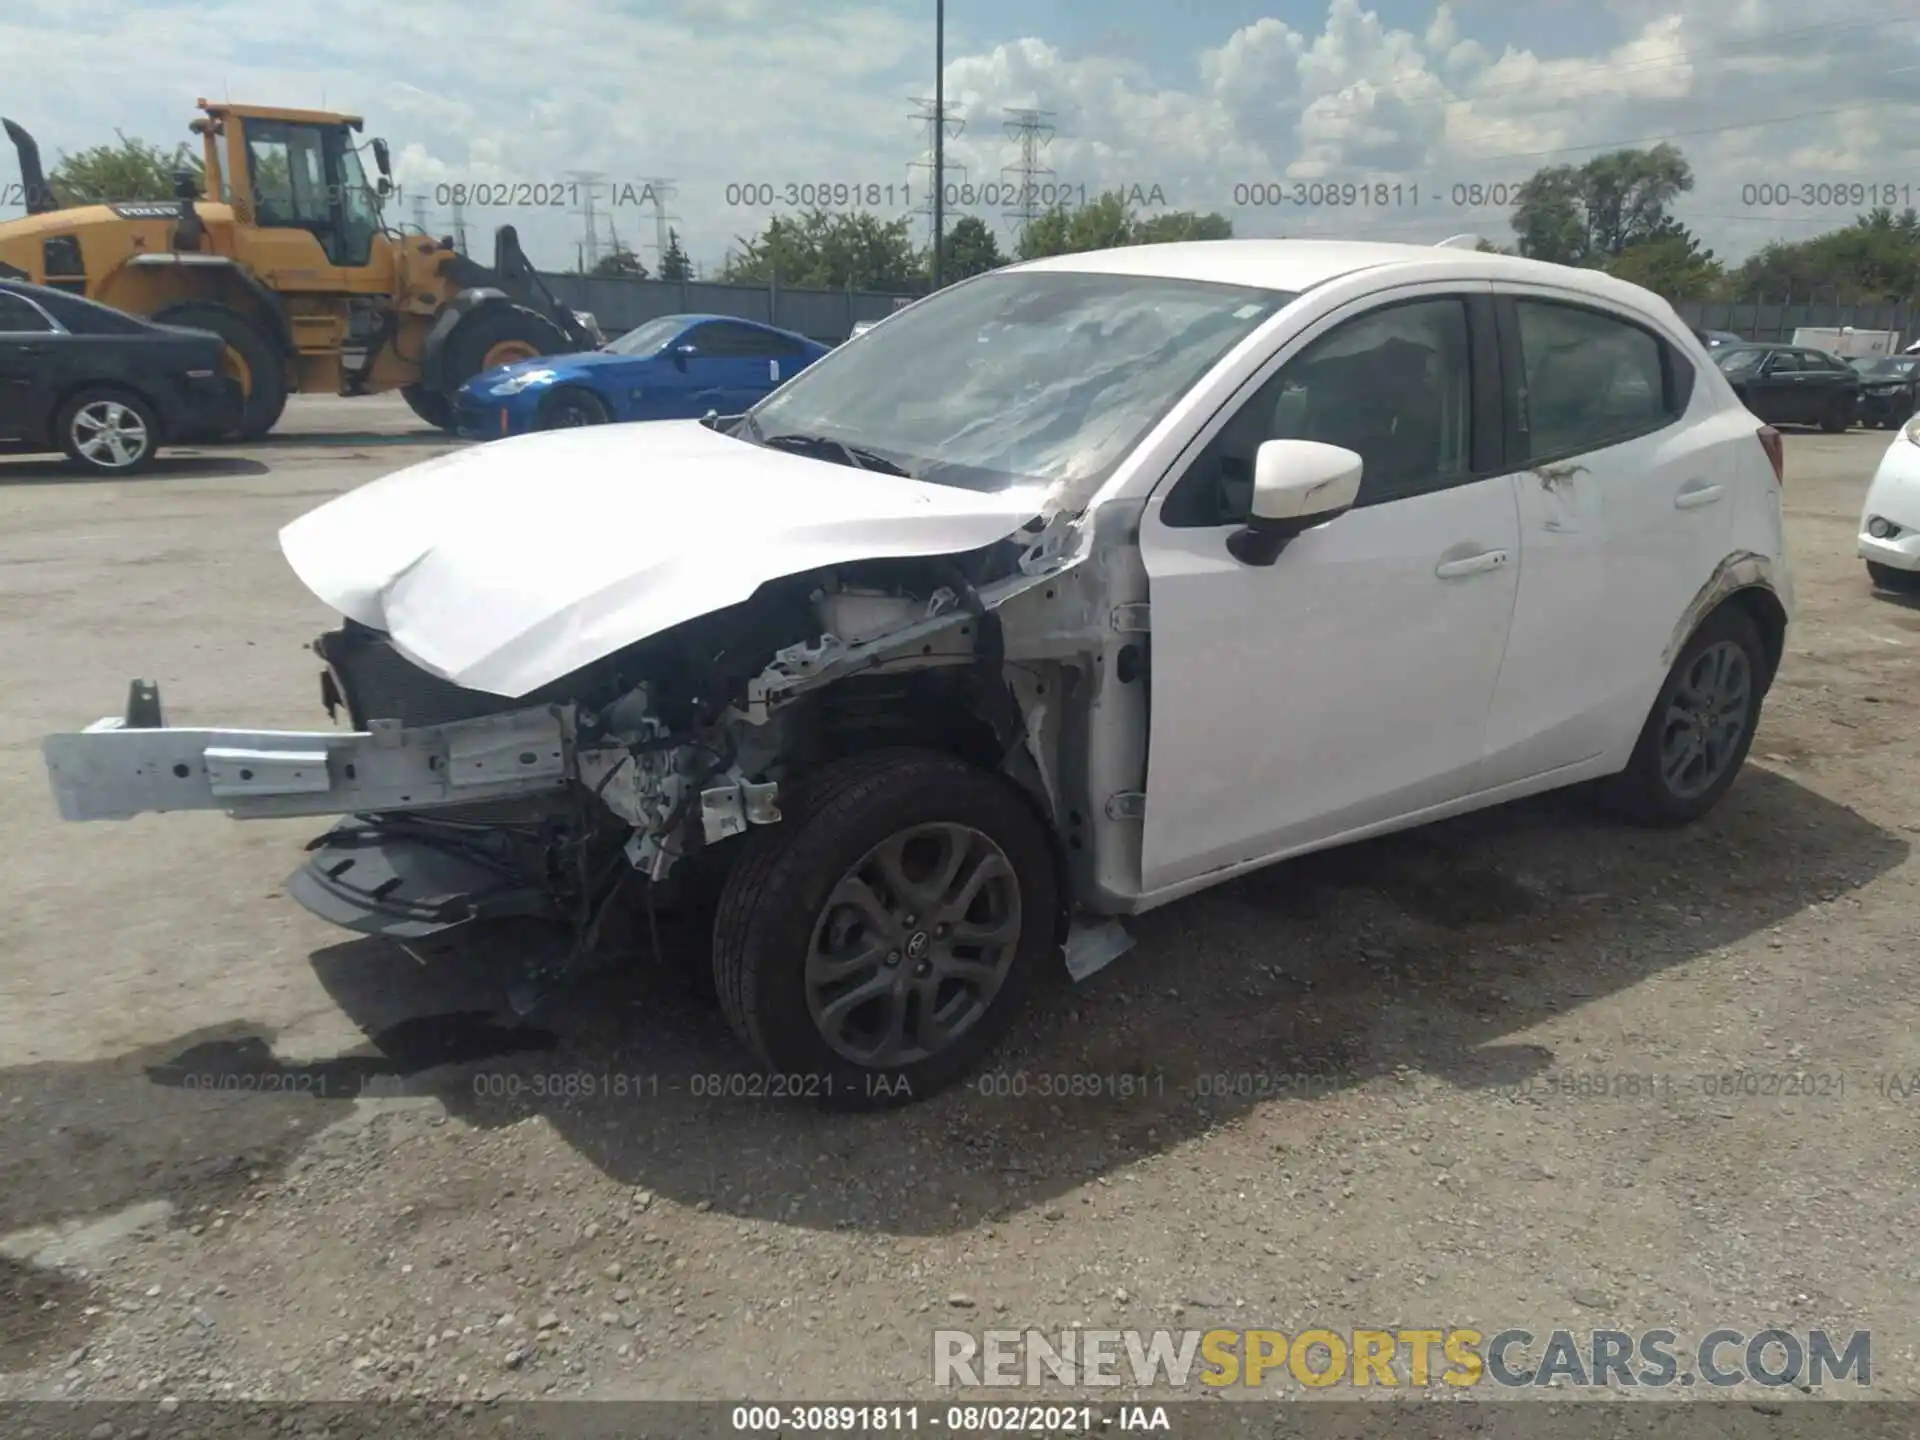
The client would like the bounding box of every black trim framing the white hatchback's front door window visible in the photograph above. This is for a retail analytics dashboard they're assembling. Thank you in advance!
[1150,280,1511,532]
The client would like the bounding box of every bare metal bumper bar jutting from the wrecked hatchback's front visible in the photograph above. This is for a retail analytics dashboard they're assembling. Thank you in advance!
[40,682,574,820]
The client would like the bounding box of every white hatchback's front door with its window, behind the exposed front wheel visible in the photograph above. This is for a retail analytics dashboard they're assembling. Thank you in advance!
[1140,284,1519,891]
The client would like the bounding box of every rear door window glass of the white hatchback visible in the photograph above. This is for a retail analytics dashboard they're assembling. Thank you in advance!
[1515,300,1693,461]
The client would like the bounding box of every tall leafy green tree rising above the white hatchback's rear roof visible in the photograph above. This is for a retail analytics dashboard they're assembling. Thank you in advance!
[1511,142,1693,267]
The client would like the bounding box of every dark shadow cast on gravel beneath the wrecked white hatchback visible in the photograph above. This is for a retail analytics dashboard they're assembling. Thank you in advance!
[278,768,1908,1235]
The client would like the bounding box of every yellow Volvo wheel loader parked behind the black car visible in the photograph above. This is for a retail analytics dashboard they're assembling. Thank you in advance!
[0,100,603,440]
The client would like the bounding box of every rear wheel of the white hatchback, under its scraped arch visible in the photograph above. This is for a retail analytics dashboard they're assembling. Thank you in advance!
[1601,605,1770,826]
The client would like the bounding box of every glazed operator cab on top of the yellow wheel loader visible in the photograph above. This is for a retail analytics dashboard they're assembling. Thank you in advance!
[196,106,388,271]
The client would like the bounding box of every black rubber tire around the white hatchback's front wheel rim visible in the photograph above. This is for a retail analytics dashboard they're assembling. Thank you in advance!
[714,749,1060,1110]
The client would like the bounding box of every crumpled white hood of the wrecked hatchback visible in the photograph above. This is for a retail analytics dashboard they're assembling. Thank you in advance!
[280,420,1044,699]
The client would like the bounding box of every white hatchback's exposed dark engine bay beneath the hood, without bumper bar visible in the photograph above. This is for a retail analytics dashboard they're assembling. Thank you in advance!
[290,534,1121,989]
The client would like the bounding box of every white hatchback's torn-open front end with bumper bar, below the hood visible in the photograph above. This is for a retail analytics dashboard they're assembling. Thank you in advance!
[44,520,1136,998]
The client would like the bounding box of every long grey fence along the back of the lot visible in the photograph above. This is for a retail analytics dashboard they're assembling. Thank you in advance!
[541,275,1920,346]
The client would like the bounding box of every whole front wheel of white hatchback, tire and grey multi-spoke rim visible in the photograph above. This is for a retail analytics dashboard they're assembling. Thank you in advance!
[714,751,1058,1110]
